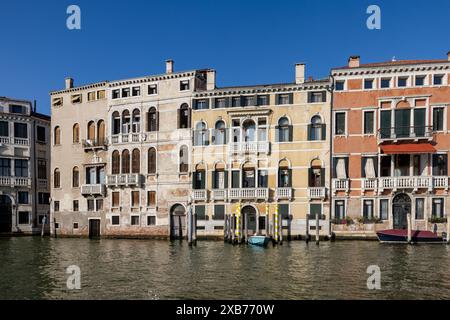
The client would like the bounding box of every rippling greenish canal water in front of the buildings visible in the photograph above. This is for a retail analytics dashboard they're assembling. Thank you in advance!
[0,237,450,299]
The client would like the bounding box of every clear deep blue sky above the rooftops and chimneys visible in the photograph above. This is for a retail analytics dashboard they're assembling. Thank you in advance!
[0,0,450,114]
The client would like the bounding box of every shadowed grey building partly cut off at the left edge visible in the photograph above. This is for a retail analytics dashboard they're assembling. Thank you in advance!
[0,97,50,234]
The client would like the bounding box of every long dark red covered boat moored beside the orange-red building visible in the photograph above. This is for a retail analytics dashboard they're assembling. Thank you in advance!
[377,229,446,243]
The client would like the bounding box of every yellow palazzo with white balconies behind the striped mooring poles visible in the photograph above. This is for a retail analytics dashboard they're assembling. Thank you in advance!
[191,64,331,237]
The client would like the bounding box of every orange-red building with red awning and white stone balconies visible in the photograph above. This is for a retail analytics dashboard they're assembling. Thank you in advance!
[331,54,450,236]
